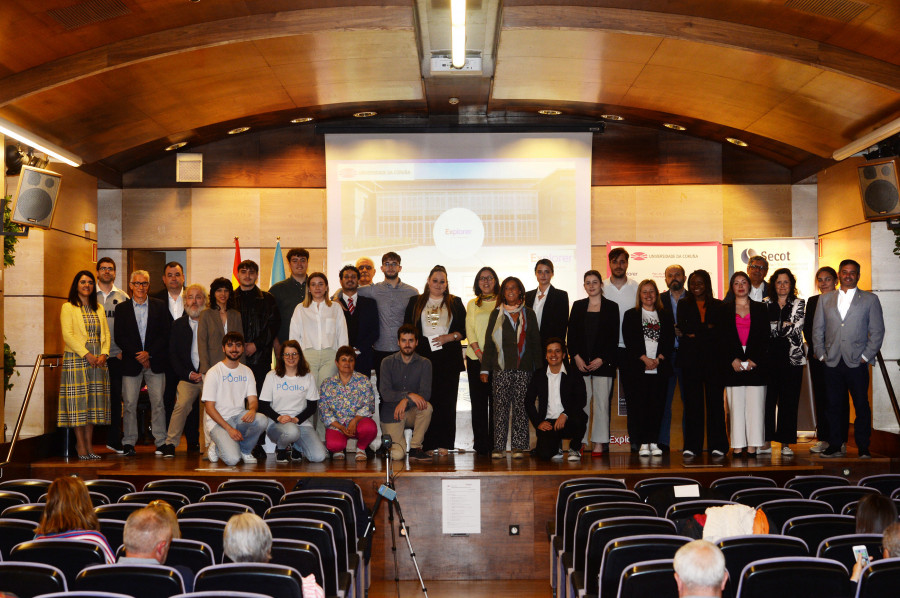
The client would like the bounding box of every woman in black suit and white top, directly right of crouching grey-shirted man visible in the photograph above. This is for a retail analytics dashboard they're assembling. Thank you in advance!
[404,266,466,455]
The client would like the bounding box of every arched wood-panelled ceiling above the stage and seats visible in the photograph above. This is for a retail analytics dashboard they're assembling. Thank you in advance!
[0,0,900,184]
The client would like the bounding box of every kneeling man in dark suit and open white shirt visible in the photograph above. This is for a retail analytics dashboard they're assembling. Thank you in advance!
[525,337,587,461]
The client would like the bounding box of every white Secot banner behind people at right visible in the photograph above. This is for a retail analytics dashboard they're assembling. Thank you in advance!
[732,237,819,297]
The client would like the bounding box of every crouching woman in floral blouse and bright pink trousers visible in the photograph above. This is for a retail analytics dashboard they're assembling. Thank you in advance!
[319,346,378,461]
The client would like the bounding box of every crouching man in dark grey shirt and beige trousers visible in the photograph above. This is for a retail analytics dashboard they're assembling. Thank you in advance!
[378,324,432,461]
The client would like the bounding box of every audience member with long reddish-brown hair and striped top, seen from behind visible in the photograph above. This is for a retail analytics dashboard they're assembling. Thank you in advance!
[34,476,116,563]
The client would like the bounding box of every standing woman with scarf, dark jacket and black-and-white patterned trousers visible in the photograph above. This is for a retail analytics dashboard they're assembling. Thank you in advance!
[481,276,543,459]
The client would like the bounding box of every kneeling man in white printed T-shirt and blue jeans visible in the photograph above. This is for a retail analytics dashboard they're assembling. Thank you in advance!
[202,332,268,465]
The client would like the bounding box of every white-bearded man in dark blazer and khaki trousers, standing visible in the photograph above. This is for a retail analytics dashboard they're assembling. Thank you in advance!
[160,284,206,457]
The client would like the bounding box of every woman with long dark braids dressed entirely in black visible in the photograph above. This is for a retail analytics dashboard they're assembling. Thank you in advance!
[675,270,728,459]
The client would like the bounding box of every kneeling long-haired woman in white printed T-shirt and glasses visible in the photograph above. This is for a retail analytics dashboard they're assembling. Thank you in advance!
[259,340,326,463]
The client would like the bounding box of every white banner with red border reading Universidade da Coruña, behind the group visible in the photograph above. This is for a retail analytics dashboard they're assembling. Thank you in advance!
[606,241,725,299]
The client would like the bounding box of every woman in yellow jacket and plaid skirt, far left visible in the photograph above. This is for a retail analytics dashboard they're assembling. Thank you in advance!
[57,270,109,461]
